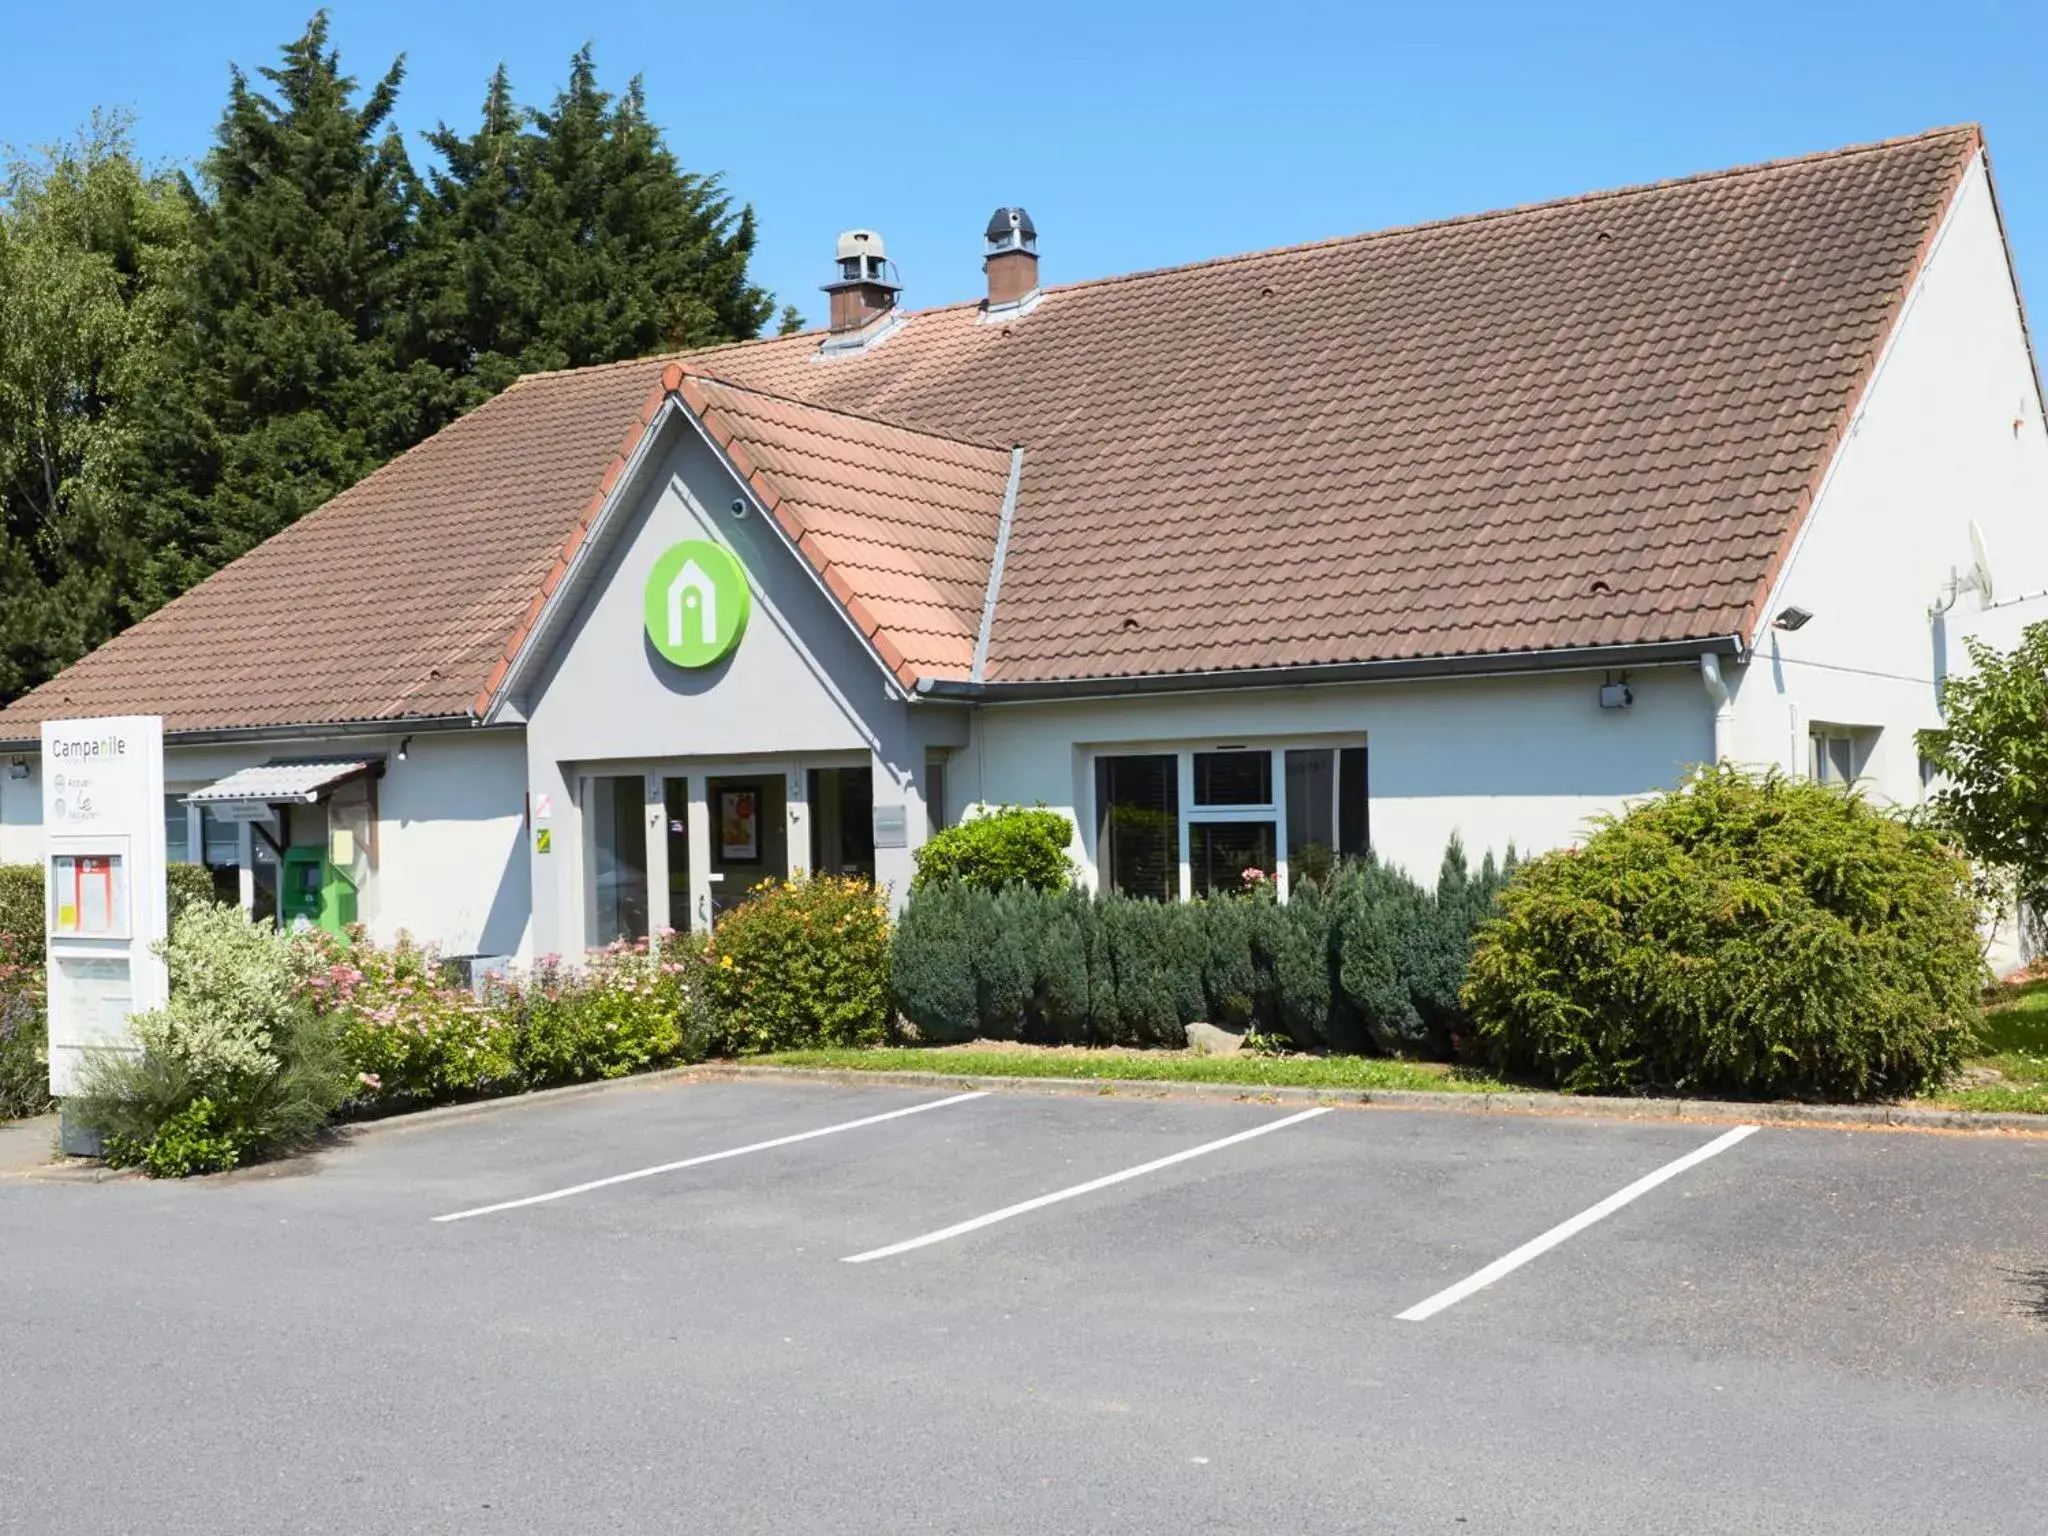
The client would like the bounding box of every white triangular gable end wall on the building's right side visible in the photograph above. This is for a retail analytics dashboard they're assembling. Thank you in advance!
[1729,162,2048,819]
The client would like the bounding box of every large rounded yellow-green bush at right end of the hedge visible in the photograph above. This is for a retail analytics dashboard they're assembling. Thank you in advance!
[1464,766,1985,1100]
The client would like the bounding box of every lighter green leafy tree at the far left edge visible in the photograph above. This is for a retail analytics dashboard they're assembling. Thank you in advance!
[0,117,190,700]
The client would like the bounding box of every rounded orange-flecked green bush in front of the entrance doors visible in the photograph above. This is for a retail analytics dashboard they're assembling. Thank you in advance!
[707,874,889,1055]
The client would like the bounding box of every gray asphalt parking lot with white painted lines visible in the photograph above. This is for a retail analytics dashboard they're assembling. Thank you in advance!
[0,1081,2048,1536]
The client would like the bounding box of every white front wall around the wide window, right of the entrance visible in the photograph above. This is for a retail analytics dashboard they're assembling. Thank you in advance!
[950,668,1712,883]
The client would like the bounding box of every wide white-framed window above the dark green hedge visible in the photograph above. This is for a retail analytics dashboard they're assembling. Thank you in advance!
[1096,743,1368,901]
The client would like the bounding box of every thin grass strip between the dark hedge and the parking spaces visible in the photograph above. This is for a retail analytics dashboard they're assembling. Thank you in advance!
[752,1047,1511,1094]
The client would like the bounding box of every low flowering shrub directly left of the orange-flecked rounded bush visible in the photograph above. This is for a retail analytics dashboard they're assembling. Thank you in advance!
[487,934,709,1087]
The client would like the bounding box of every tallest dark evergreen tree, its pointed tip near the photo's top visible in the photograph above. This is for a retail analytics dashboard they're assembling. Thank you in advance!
[137,12,459,610]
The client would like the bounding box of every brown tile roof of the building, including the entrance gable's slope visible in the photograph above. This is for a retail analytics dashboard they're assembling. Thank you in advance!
[0,129,1980,739]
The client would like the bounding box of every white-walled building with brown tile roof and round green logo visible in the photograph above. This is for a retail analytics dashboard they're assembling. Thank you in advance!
[0,131,2048,961]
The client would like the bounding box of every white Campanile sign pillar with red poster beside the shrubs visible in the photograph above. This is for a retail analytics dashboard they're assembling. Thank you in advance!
[43,715,170,1151]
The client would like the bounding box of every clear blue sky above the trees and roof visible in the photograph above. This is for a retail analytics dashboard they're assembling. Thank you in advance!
[0,0,2048,334]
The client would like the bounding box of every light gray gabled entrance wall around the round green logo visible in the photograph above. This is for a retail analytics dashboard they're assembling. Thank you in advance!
[514,414,967,954]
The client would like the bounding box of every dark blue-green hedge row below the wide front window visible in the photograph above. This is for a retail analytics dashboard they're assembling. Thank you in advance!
[893,840,1511,1055]
